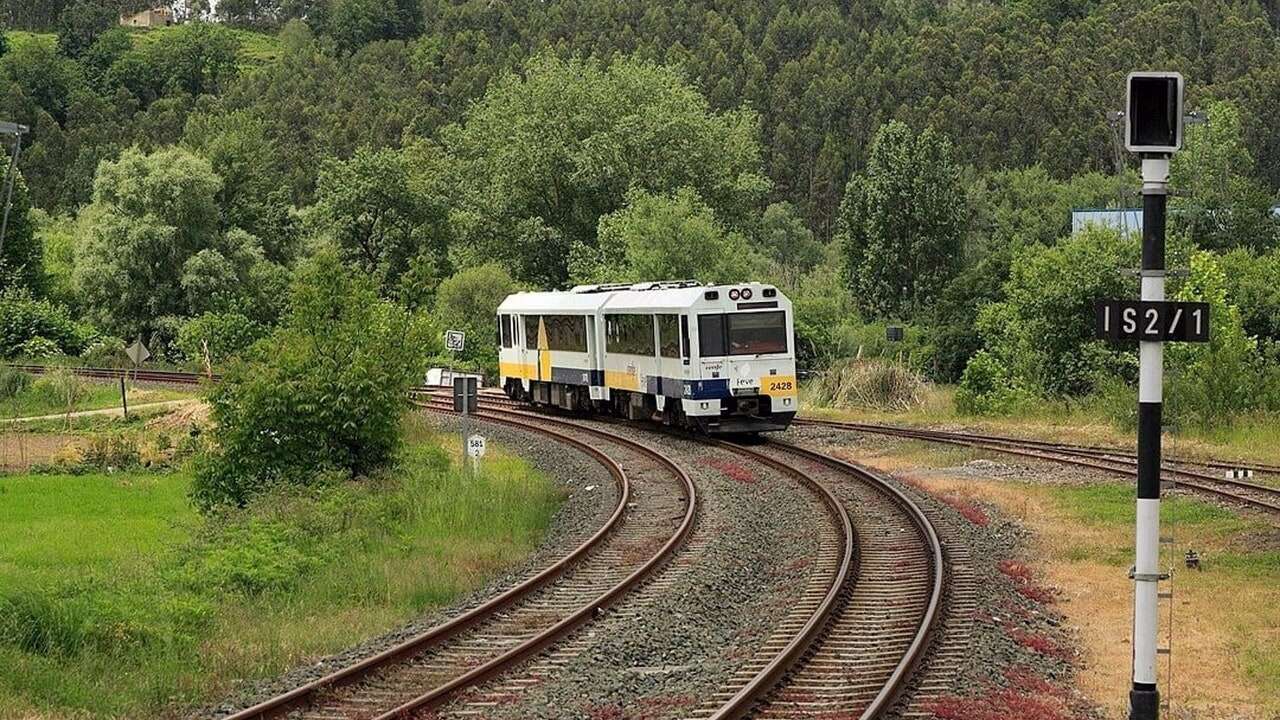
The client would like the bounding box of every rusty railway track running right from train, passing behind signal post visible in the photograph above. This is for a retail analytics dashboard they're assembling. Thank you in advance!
[796,419,1280,515]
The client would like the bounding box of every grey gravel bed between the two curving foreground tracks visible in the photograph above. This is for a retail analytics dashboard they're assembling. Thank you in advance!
[449,424,827,719]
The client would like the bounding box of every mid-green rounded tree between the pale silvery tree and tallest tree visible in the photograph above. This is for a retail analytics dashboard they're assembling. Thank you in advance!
[308,150,448,293]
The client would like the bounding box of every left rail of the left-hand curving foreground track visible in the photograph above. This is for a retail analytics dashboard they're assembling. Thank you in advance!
[224,399,645,720]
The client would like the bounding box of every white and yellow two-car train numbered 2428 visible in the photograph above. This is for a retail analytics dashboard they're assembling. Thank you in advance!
[498,282,797,434]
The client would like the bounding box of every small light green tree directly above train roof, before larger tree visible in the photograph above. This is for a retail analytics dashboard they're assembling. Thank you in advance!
[570,187,754,282]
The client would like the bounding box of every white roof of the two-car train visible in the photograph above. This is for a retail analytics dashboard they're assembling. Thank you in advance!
[498,281,790,313]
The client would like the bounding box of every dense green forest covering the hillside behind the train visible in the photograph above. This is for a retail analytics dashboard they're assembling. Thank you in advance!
[0,0,1280,423]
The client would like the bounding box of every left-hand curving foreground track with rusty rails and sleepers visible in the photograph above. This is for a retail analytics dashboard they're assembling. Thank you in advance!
[227,404,698,720]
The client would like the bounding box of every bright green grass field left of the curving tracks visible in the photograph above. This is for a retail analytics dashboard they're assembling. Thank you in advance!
[0,420,561,717]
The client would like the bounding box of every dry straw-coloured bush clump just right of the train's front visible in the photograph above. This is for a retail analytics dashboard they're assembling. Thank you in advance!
[814,357,925,410]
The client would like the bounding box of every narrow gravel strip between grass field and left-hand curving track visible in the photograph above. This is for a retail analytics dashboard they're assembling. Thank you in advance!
[192,414,618,720]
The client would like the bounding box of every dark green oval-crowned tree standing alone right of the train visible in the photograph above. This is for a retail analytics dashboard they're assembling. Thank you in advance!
[837,122,964,318]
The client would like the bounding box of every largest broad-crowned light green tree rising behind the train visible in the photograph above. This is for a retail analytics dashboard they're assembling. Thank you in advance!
[445,55,768,286]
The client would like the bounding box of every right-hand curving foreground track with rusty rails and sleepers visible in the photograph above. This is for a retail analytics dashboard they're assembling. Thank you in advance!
[694,442,946,720]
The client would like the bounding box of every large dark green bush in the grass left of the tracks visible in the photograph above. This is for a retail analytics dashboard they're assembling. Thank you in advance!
[192,252,439,511]
